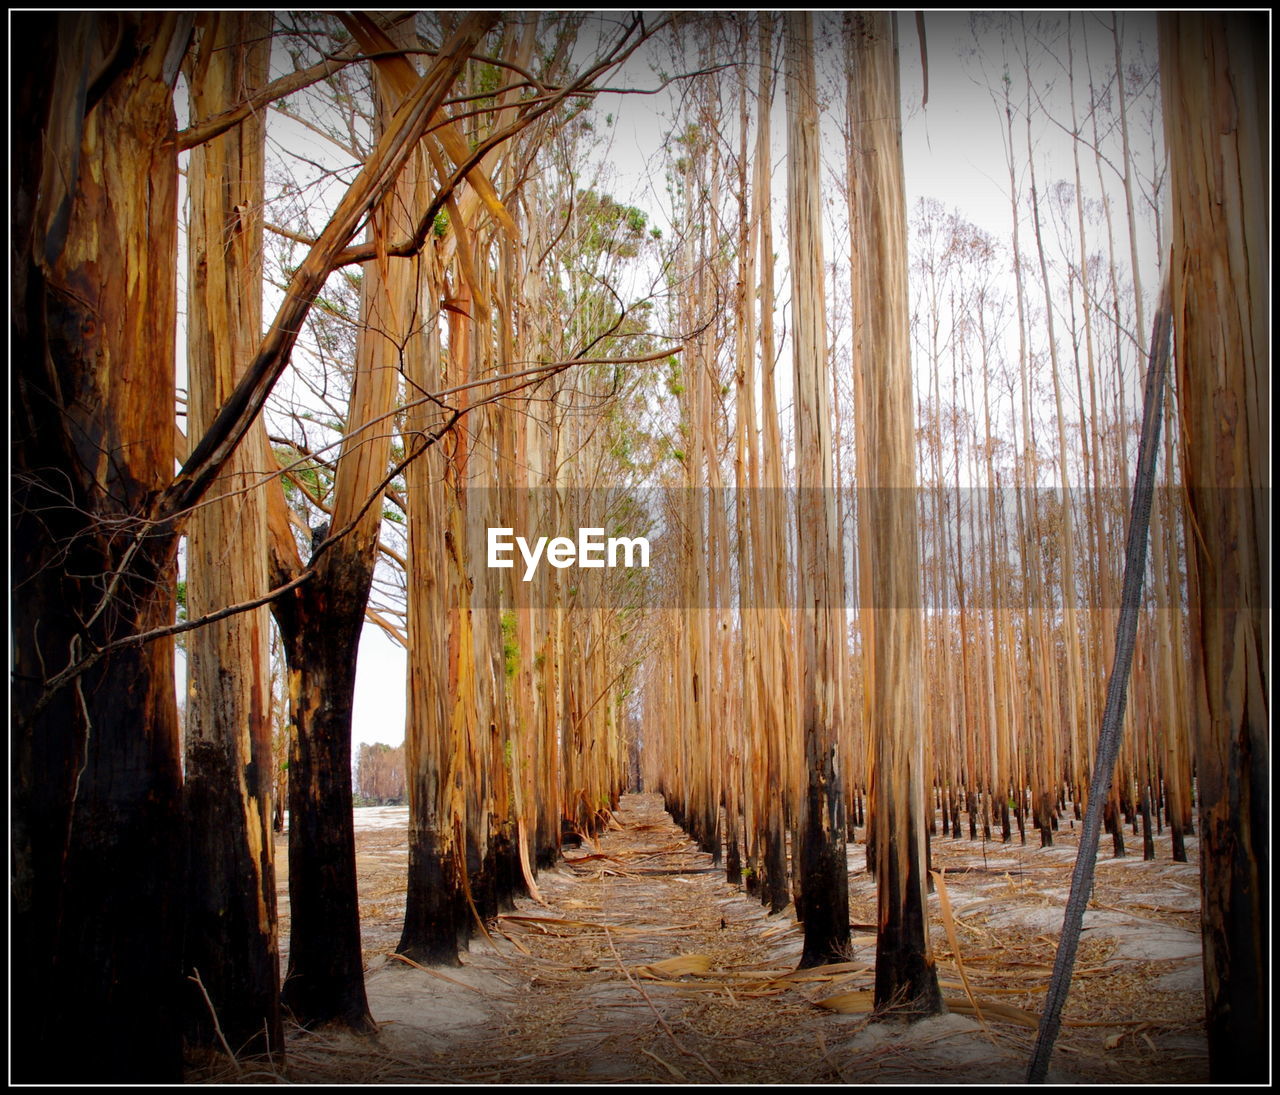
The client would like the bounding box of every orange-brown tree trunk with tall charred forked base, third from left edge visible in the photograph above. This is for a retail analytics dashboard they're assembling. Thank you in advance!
[274,19,471,1031]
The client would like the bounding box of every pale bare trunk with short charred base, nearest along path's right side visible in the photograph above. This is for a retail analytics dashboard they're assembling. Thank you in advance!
[856,14,942,1016]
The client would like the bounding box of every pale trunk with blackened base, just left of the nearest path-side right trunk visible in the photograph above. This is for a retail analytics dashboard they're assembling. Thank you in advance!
[786,13,849,967]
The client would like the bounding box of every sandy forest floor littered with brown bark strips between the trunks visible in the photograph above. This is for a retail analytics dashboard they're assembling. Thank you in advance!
[204,794,1208,1083]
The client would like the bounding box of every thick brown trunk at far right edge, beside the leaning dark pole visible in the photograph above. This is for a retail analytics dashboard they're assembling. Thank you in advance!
[1160,14,1271,1082]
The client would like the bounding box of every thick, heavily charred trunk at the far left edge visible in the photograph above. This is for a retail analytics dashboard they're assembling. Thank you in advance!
[10,14,191,1082]
